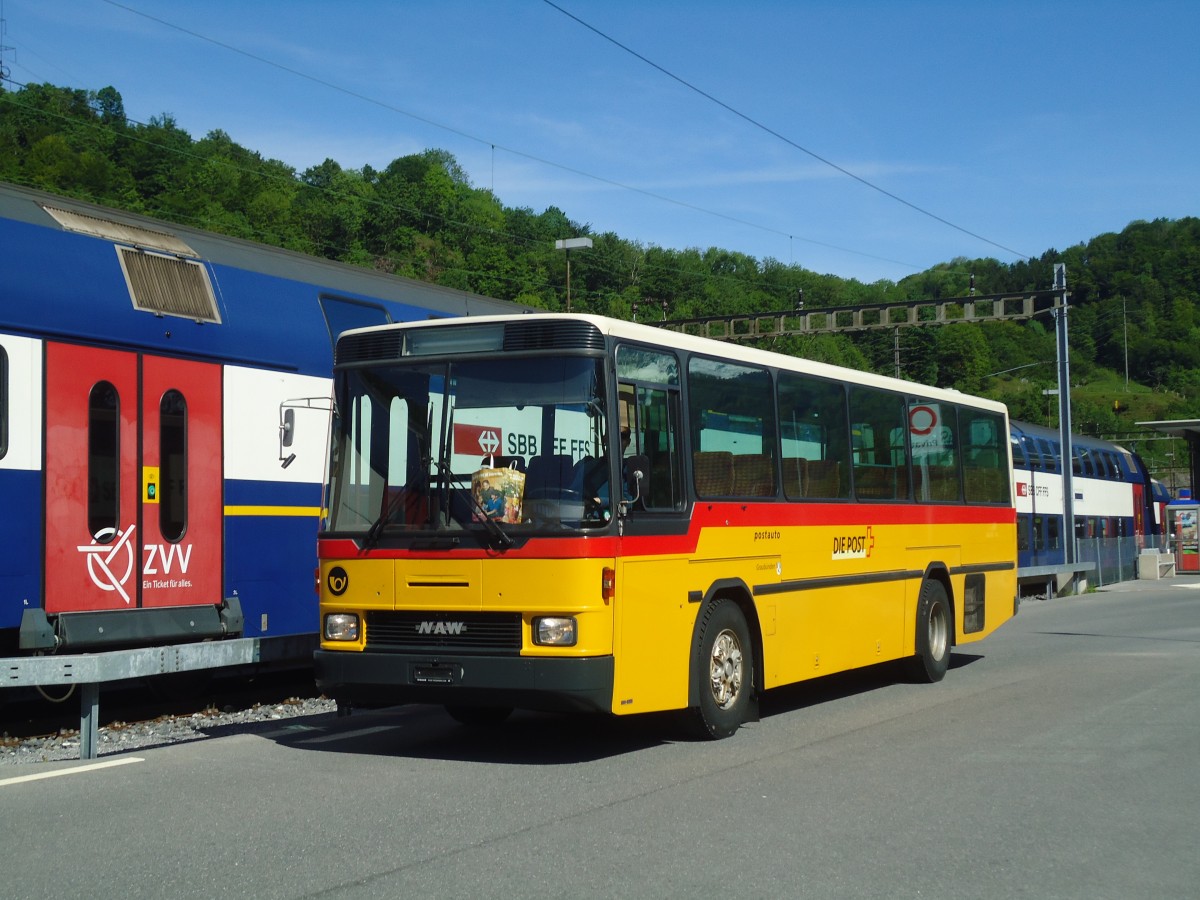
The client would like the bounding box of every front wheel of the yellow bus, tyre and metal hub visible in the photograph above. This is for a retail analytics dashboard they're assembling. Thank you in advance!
[692,600,754,739]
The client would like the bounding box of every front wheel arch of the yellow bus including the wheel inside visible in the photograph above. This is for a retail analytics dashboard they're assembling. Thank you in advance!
[688,582,762,739]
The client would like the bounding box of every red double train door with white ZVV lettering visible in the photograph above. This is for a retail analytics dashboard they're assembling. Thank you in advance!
[44,343,223,614]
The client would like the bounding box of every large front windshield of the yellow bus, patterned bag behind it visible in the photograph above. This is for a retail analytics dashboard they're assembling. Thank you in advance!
[326,355,612,542]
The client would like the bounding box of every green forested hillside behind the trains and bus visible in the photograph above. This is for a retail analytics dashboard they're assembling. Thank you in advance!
[0,85,1200,458]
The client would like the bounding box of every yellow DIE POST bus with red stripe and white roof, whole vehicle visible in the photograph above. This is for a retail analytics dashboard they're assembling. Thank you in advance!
[316,314,1016,737]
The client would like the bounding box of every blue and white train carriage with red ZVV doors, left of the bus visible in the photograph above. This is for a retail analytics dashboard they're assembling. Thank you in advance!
[0,185,521,659]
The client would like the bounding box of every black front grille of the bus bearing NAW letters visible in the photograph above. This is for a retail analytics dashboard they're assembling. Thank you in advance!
[366,610,521,655]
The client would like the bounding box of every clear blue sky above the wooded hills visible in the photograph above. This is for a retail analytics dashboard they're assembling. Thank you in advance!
[0,0,1200,282]
